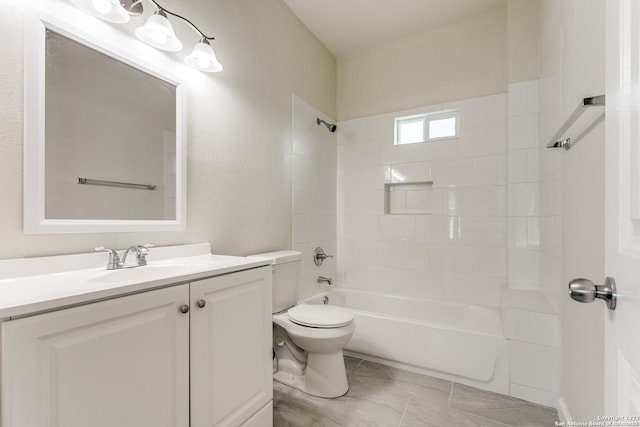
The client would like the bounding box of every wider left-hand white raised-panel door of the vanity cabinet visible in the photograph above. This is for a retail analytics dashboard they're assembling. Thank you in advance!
[2,285,189,427]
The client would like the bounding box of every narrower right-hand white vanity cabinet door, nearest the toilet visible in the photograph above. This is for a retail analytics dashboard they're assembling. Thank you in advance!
[191,267,273,427]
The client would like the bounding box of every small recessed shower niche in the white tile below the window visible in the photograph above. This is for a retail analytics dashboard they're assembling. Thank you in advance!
[384,181,434,215]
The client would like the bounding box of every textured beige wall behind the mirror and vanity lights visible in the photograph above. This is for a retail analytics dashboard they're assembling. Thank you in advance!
[0,0,336,258]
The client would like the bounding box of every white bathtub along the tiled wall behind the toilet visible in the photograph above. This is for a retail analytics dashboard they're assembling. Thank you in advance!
[307,288,509,393]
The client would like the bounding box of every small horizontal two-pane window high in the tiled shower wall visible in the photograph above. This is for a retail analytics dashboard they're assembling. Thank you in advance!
[395,111,458,145]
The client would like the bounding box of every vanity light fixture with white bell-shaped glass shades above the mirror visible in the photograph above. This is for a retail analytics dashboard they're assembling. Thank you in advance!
[72,0,223,73]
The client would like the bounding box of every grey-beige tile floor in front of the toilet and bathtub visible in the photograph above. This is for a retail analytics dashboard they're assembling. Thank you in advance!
[273,357,558,427]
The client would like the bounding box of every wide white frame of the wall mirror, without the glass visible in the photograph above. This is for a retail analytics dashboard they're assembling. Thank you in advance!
[23,8,187,234]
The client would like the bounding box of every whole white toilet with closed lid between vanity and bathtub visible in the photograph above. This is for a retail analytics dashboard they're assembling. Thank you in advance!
[251,251,355,397]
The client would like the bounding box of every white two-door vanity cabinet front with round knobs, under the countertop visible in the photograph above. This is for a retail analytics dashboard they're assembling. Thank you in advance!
[1,267,272,427]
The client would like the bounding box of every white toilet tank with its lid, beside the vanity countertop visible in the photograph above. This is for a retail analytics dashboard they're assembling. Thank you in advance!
[250,250,302,313]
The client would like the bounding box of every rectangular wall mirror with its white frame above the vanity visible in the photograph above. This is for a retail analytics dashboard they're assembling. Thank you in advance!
[24,14,186,234]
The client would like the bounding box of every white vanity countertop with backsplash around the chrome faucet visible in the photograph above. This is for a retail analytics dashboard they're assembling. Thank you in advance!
[0,243,269,319]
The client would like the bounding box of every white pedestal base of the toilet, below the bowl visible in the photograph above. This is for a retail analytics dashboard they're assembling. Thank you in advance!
[273,350,349,398]
